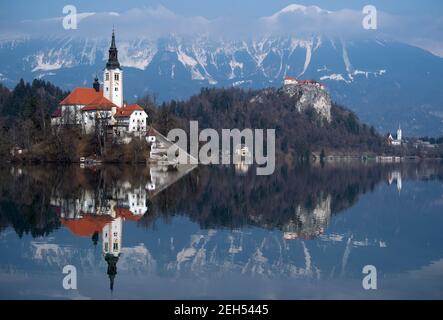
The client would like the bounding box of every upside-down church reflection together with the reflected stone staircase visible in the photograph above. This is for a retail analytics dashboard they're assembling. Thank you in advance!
[51,165,195,290]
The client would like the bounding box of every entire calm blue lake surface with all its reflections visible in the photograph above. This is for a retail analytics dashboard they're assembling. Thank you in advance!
[0,162,443,299]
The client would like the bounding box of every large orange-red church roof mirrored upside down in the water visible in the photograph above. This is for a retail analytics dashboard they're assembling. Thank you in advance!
[60,215,112,237]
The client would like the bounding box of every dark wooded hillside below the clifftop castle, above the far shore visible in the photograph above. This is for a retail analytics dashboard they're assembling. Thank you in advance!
[148,88,383,157]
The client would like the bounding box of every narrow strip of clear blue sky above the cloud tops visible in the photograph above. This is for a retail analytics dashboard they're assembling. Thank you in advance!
[0,0,443,21]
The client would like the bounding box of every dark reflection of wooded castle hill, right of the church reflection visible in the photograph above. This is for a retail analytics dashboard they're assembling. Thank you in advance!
[142,163,443,238]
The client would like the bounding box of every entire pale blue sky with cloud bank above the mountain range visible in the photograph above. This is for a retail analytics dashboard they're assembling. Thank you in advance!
[0,0,443,56]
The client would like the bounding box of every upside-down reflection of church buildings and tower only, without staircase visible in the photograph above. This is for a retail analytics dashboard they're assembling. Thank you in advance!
[51,182,148,290]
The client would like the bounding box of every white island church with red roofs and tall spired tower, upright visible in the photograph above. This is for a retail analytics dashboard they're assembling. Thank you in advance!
[51,31,148,143]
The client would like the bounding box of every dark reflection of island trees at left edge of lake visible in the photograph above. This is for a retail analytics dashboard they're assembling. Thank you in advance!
[0,166,149,237]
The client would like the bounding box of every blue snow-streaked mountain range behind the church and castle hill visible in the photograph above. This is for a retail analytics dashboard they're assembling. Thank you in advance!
[0,5,443,135]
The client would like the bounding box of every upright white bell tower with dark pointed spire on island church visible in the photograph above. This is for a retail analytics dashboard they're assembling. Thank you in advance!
[103,30,123,107]
